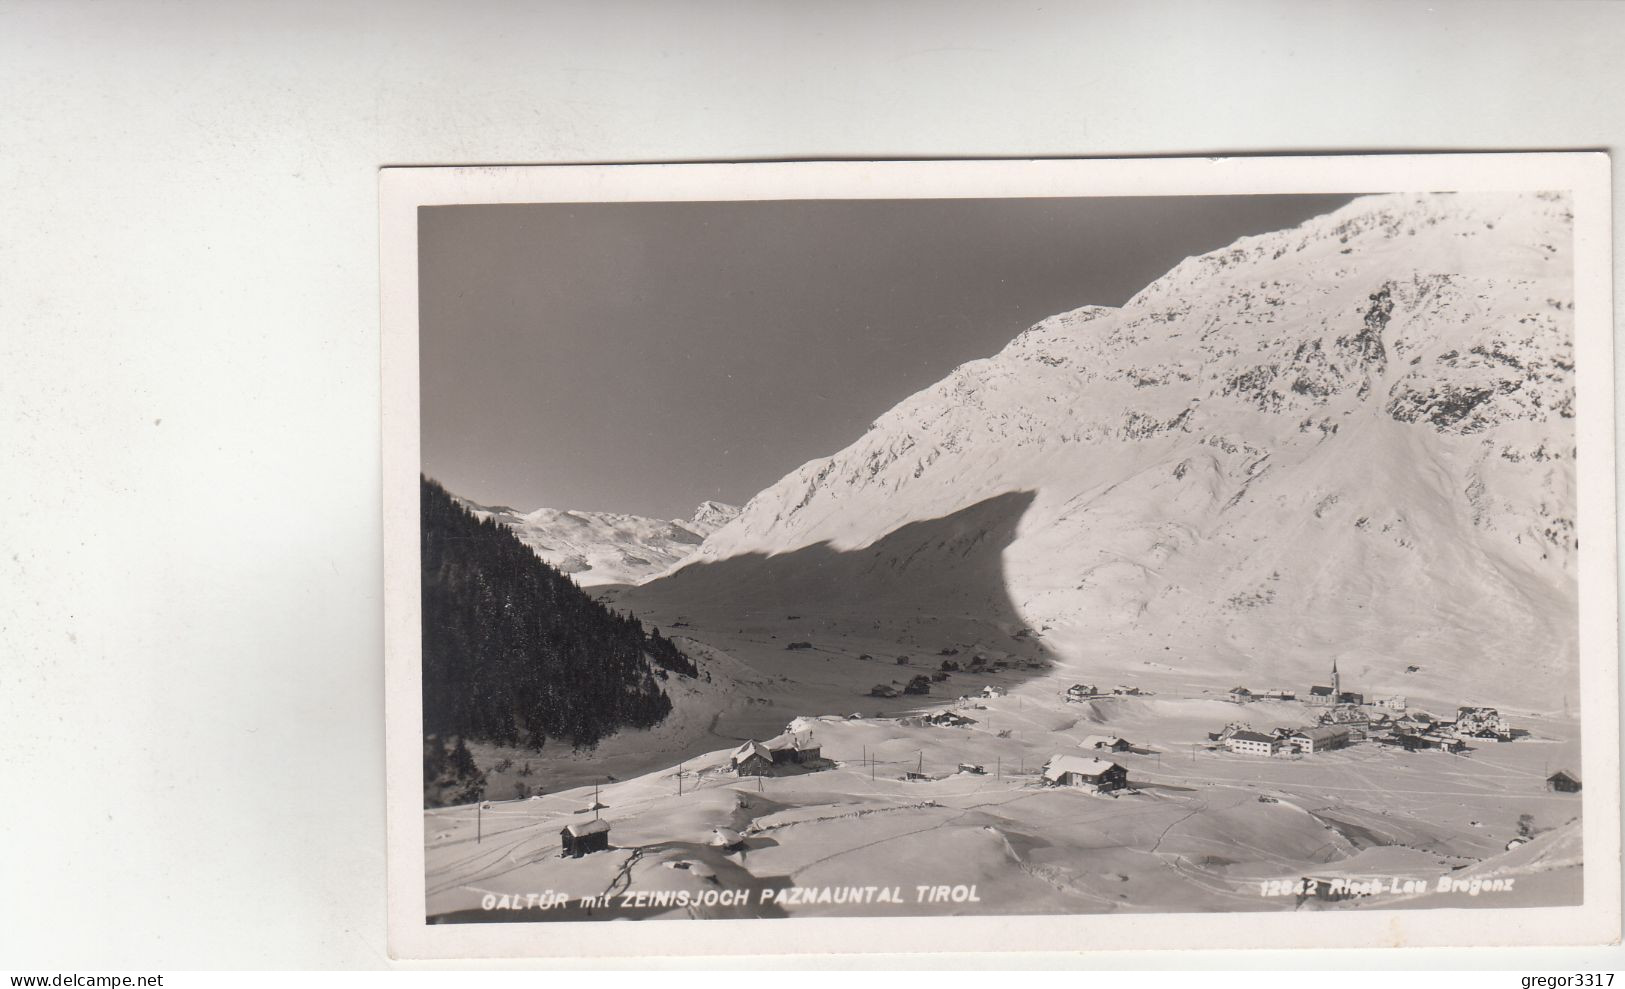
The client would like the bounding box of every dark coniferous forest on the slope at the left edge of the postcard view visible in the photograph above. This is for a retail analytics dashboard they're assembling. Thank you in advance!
[421,477,697,786]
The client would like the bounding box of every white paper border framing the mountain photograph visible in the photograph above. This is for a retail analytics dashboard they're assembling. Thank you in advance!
[380,153,1620,958]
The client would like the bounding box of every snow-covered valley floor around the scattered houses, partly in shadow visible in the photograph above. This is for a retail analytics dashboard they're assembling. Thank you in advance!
[424,604,1581,922]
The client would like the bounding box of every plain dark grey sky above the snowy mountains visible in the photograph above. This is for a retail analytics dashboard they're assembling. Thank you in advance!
[419,195,1350,518]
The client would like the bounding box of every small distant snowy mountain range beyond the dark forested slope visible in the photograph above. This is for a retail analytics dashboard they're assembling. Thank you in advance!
[458,499,739,586]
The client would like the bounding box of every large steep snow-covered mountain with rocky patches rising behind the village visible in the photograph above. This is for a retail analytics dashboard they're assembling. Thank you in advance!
[639,193,1576,706]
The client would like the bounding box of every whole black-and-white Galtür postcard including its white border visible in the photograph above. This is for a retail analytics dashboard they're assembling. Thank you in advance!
[380,153,1620,957]
